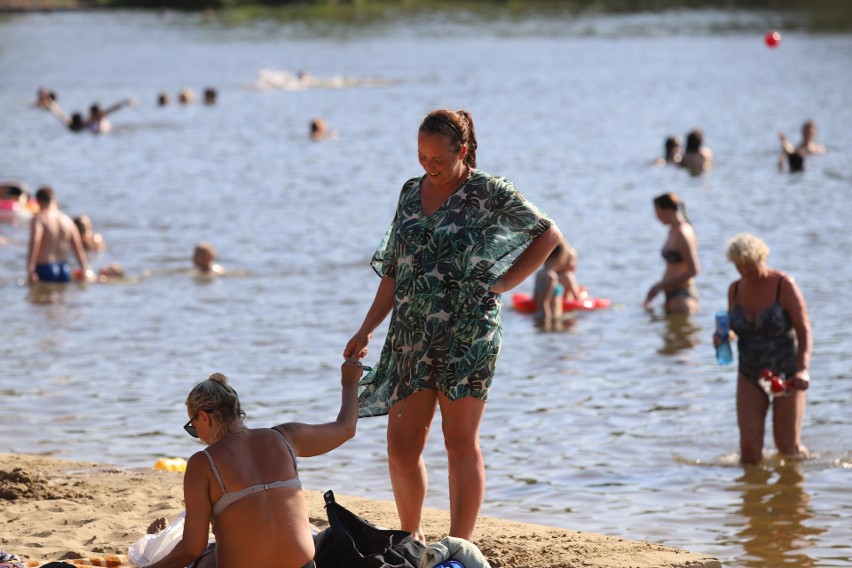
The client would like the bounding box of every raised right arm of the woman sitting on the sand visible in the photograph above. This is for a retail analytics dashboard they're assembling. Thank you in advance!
[275,359,363,457]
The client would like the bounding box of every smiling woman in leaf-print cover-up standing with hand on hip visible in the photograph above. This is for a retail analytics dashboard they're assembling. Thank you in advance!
[344,109,562,540]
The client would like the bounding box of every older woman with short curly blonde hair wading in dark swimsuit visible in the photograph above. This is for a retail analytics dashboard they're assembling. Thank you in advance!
[714,233,813,464]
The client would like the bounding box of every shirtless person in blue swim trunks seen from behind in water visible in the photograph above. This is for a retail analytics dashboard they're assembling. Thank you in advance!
[27,187,91,282]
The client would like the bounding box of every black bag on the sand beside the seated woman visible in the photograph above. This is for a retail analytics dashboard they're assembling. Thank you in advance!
[314,491,426,568]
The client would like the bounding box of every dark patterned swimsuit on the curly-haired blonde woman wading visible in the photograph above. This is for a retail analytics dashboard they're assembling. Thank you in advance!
[730,276,798,384]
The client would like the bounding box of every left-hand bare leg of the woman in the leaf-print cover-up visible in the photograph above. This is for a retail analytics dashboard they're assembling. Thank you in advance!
[388,390,438,540]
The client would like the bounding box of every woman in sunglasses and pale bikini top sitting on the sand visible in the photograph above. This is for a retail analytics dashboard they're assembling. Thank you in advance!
[141,360,362,568]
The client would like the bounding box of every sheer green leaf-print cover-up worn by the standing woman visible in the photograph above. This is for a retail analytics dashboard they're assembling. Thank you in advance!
[359,170,553,417]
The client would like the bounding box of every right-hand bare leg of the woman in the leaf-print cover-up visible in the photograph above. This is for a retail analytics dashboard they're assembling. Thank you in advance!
[438,394,485,540]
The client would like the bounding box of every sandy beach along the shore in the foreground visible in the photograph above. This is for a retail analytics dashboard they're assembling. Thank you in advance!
[0,454,721,568]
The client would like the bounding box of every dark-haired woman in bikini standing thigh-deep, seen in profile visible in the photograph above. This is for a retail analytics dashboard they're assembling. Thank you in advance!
[645,193,699,314]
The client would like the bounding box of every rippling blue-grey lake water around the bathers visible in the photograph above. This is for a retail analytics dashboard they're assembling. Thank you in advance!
[0,5,852,567]
